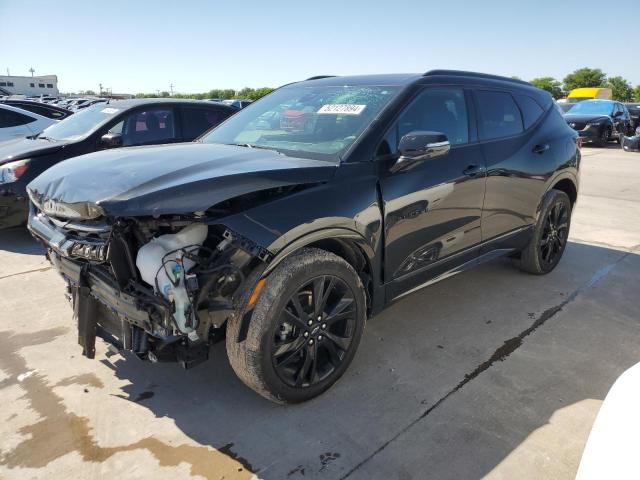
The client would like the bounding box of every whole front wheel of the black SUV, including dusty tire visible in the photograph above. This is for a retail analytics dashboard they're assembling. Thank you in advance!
[226,248,366,403]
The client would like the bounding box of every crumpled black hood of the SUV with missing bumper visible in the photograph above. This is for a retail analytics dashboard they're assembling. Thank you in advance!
[27,143,336,216]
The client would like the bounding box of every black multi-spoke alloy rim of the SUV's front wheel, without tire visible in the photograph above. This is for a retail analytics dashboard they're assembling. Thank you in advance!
[272,275,357,388]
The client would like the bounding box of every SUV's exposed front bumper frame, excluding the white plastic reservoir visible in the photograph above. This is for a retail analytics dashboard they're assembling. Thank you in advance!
[28,208,268,368]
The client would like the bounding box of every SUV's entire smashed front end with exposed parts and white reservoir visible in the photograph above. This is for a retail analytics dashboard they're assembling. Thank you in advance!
[29,205,271,368]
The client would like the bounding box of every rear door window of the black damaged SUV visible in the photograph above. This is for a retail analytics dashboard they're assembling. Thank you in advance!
[476,90,523,140]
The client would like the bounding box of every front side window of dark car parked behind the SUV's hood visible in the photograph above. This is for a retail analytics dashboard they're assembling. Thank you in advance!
[119,108,176,147]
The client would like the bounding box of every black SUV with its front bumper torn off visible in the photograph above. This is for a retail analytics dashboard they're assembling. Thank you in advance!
[29,71,580,403]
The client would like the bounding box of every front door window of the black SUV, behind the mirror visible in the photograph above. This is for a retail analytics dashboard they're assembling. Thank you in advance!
[376,87,469,156]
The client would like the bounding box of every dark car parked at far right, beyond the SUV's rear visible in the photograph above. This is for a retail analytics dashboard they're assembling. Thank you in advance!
[564,100,633,147]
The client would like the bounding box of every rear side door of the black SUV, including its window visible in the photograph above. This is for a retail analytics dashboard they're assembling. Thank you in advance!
[474,90,552,250]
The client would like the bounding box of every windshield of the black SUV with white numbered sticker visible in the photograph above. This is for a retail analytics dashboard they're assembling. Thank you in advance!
[200,85,398,162]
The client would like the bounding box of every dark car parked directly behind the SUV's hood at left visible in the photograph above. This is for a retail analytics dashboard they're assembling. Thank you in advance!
[0,99,237,228]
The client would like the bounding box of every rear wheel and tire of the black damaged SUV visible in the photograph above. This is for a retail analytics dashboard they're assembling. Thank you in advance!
[518,190,571,275]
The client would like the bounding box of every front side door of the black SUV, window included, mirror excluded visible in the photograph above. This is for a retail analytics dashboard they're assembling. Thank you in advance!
[381,87,485,300]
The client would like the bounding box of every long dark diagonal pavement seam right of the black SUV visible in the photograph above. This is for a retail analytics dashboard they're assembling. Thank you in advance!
[340,252,633,480]
